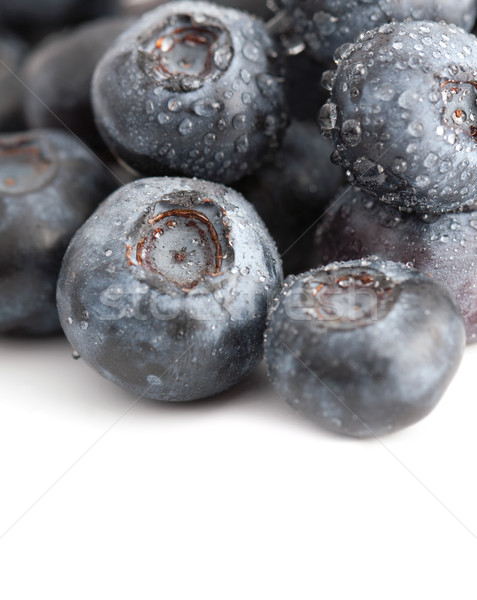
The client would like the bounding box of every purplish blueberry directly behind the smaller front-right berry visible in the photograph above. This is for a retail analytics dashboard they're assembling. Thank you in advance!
[314,188,477,343]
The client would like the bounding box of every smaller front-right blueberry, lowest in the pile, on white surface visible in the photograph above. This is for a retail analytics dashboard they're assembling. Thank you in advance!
[265,259,465,437]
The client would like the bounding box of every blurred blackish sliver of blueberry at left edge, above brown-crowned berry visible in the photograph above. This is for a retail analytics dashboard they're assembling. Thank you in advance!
[0,30,27,131]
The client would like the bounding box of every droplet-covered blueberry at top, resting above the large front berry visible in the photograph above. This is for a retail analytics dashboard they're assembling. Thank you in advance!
[92,1,288,183]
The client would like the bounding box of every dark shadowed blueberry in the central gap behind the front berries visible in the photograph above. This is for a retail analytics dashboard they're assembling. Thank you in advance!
[236,121,343,273]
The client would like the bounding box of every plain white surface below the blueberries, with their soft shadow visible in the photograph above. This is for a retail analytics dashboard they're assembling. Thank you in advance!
[0,339,477,600]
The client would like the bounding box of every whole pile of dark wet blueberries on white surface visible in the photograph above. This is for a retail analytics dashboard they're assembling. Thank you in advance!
[0,0,477,437]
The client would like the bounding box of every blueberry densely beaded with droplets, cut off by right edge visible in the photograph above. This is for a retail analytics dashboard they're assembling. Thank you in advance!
[320,22,477,213]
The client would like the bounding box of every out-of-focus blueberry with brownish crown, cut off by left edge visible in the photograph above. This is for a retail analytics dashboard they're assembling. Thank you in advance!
[0,130,115,335]
